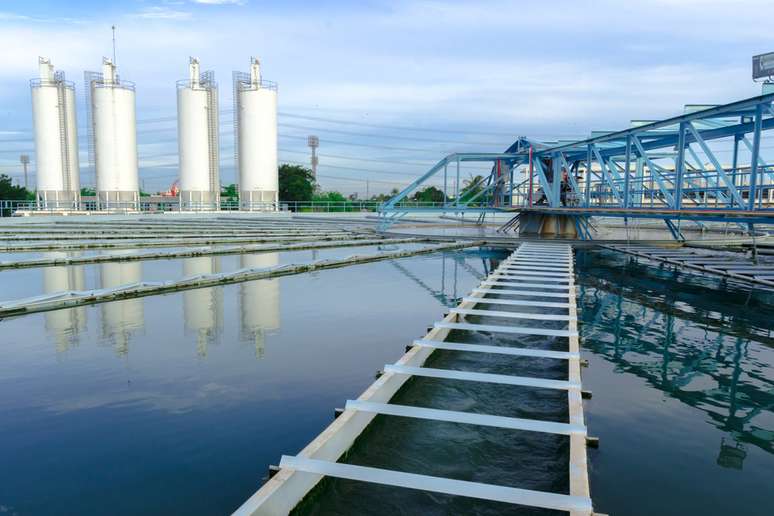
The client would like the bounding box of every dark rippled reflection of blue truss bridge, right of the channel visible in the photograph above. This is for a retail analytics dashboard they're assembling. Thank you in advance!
[578,255,774,458]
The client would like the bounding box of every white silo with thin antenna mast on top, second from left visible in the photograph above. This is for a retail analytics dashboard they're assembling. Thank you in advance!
[85,58,140,209]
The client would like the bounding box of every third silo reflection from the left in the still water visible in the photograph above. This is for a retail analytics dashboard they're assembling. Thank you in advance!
[183,256,223,356]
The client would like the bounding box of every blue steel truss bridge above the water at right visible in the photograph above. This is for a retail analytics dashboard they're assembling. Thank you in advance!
[380,94,774,238]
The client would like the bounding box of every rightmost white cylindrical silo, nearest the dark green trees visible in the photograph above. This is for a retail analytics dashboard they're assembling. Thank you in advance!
[234,58,279,210]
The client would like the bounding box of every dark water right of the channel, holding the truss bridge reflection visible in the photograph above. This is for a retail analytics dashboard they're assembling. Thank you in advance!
[576,251,774,515]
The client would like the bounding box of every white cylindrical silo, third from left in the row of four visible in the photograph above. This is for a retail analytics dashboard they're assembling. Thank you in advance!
[177,58,220,210]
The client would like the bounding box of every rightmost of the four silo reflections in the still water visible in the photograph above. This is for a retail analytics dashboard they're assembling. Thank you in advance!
[240,253,280,357]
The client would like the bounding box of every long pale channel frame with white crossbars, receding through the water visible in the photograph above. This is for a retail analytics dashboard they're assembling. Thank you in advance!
[235,243,593,516]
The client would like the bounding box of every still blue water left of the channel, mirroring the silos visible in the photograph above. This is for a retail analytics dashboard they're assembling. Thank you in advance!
[0,249,484,515]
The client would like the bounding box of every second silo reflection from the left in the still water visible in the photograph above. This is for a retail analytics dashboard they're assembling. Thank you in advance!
[100,251,145,355]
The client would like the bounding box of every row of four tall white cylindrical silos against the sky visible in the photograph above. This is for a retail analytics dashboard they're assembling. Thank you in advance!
[31,58,279,210]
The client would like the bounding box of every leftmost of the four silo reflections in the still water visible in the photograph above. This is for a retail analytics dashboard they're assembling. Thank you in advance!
[43,251,86,352]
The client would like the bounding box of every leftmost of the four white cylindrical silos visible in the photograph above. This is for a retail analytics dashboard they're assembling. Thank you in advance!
[30,57,81,210]
